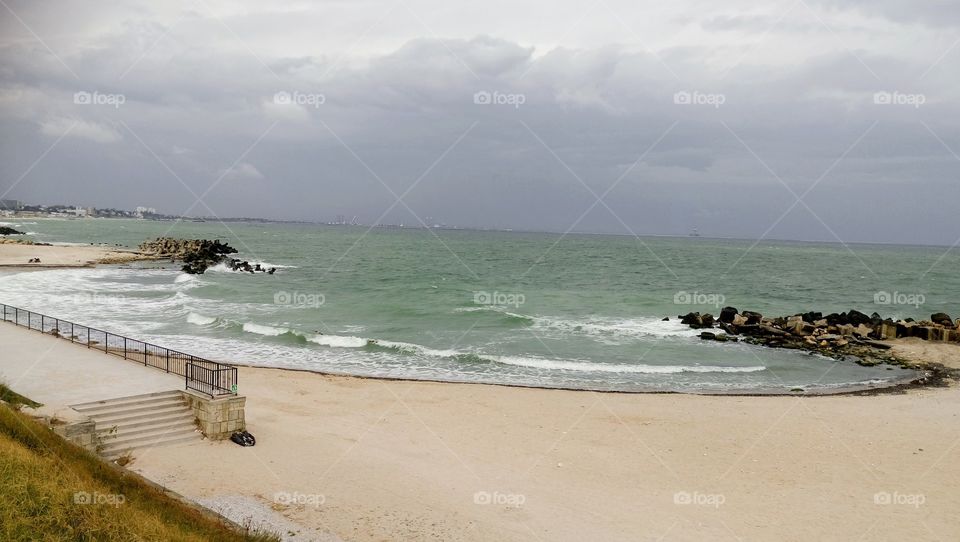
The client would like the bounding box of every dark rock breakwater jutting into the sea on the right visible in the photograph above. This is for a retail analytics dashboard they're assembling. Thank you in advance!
[680,307,960,365]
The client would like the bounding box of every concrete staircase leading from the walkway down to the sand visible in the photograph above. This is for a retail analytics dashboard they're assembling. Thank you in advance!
[72,390,203,459]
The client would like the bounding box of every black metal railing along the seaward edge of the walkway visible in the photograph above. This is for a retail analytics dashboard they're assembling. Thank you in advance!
[0,303,237,397]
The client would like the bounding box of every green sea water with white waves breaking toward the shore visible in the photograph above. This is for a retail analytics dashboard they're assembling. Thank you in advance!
[0,219,960,392]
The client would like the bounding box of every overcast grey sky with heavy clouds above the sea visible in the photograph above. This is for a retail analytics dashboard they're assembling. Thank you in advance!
[0,0,960,246]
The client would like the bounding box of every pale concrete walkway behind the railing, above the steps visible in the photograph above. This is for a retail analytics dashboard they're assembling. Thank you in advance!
[0,322,184,409]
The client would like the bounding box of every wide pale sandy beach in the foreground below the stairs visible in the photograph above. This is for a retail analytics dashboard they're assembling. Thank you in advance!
[118,368,960,540]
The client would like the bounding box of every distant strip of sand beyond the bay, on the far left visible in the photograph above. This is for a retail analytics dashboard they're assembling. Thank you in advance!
[0,242,144,269]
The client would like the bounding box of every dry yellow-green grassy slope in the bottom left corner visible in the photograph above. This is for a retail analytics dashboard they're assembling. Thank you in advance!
[0,402,279,541]
